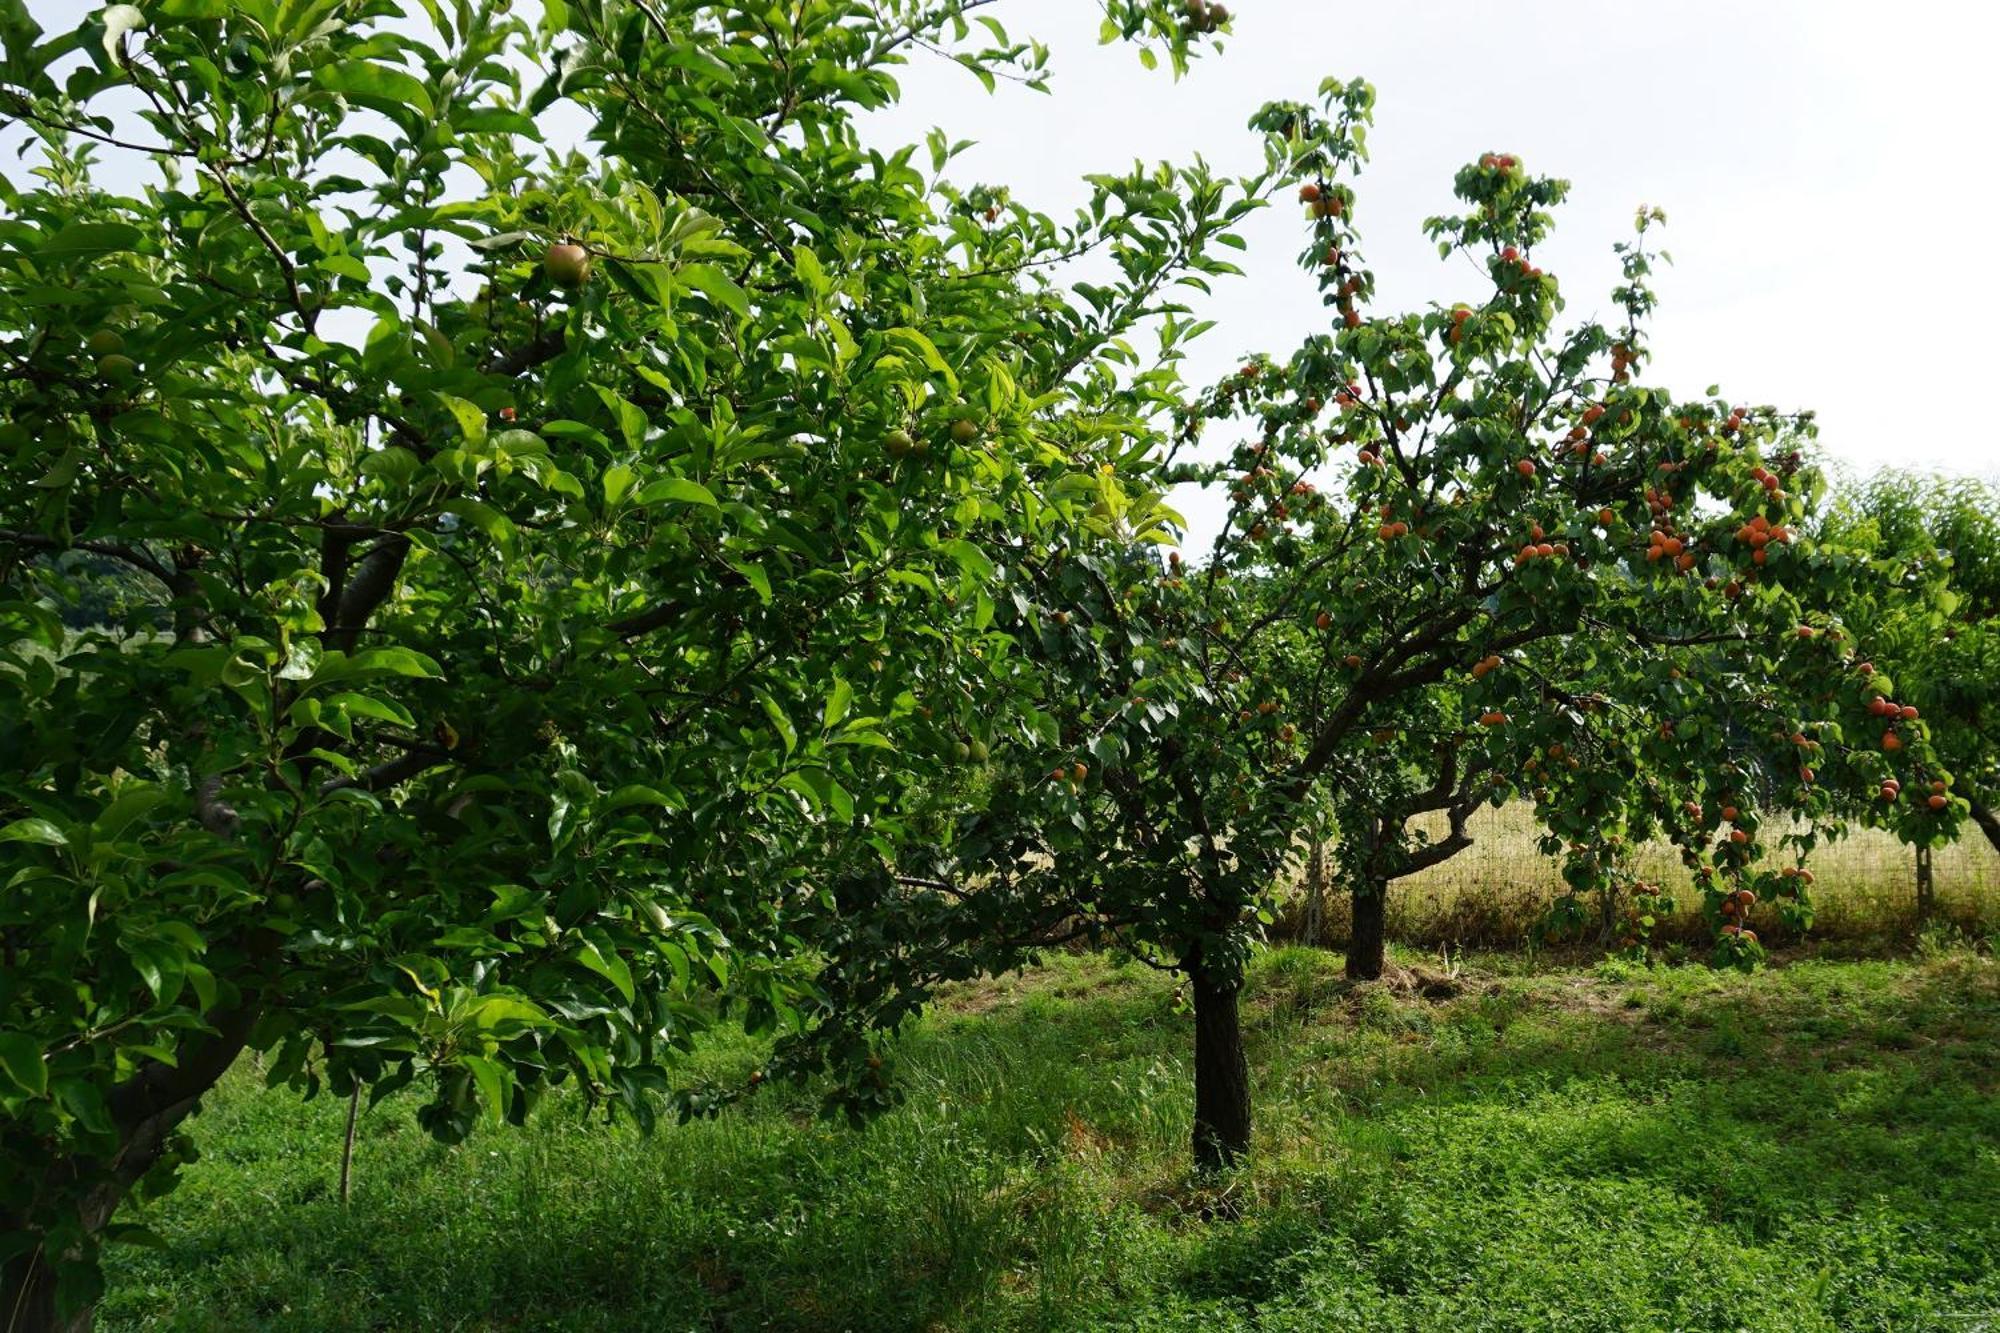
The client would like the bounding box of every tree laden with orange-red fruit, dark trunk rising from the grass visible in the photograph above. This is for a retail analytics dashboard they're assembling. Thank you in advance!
[792,82,1962,1167]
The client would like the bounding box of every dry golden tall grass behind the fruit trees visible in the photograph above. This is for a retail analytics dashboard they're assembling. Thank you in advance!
[1274,807,2000,949]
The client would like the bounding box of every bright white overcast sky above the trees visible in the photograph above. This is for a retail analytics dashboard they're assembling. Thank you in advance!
[6,0,2000,548]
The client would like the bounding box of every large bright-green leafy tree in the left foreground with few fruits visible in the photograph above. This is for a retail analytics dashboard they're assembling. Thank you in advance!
[0,0,1248,1329]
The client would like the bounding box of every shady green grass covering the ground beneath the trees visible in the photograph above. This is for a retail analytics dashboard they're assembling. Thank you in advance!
[102,949,2000,1331]
